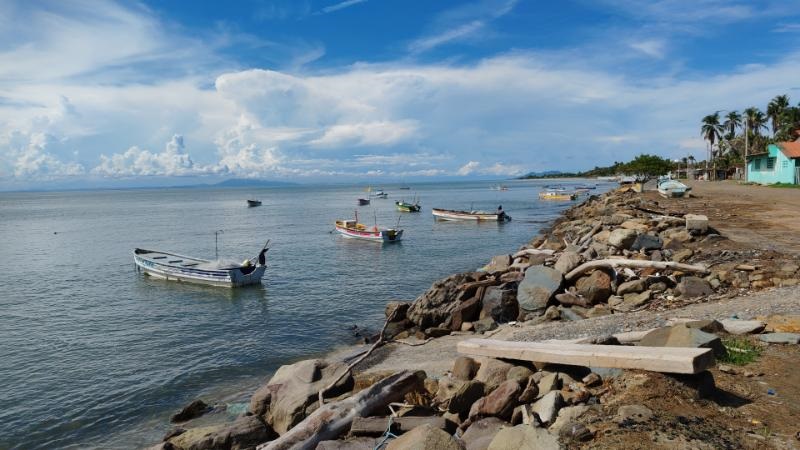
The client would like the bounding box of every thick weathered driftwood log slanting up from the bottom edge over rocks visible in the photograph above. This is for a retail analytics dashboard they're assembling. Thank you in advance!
[257,370,421,450]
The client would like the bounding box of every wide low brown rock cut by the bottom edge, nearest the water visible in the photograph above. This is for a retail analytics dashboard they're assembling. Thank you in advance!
[169,416,277,450]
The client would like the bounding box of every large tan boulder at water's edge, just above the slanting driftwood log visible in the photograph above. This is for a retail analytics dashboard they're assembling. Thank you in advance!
[250,359,353,434]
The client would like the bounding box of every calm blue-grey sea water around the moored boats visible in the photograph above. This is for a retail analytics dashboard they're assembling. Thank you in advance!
[0,181,608,449]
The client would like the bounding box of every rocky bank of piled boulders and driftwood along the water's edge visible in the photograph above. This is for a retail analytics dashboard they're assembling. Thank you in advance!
[145,186,800,450]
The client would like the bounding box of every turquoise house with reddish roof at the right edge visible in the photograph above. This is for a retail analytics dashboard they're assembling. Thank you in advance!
[747,140,800,184]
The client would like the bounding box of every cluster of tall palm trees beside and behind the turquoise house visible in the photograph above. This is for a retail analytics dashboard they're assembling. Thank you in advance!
[700,95,800,168]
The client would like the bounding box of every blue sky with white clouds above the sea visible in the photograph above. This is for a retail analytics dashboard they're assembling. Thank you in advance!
[0,0,800,190]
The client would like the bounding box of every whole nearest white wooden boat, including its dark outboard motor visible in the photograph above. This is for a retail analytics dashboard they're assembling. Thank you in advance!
[133,242,269,287]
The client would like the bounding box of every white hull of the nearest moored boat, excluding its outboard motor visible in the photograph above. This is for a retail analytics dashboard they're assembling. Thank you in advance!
[133,249,267,288]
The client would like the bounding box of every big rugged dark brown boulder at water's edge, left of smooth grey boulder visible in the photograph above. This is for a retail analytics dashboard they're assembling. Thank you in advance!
[406,273,473,330]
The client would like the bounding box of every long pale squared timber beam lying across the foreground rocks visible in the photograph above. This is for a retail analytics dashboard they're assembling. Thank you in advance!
[458,339,714,374]
